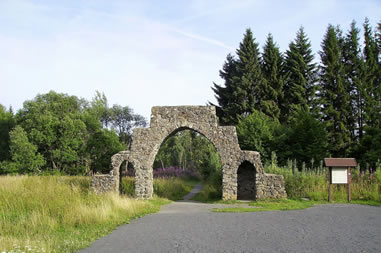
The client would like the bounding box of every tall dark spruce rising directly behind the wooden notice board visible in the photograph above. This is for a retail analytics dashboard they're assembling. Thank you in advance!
[319,25,350,157]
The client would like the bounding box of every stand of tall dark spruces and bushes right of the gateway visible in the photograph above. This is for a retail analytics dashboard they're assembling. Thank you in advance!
[212,19,381,169]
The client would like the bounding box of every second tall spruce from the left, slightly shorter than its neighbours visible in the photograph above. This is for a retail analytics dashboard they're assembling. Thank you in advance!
[259,34,285,119]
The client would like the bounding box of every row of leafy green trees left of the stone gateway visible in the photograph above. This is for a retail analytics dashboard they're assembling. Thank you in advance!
[0,91,147,175]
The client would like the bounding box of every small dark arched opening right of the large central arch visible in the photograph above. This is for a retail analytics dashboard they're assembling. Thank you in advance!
[237,161,257,200]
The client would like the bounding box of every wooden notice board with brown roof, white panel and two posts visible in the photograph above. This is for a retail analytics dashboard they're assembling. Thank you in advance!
[324,158,357,202]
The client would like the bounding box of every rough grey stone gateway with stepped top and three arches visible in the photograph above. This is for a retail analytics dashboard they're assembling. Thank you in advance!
[91,106,287,200]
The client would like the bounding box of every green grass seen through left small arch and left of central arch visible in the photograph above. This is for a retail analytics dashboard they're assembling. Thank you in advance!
[122,177,198,201]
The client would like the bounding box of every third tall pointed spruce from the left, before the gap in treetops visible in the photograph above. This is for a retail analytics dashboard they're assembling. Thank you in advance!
[281,27,317,121]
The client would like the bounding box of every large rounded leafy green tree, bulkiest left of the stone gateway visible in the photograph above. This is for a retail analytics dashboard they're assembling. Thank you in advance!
[16,91,88,173]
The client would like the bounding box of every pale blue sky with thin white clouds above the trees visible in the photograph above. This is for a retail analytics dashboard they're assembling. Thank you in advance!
[0,0,381,118]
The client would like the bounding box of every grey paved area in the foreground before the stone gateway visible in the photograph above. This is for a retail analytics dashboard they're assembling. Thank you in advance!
[81,186,381,253]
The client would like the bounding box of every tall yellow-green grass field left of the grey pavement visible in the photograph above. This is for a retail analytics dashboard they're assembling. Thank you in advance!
[0,176,169,252]
